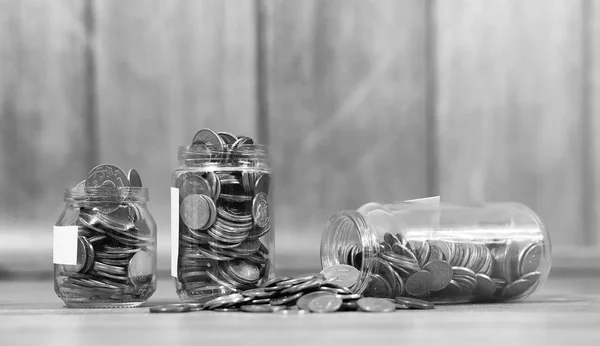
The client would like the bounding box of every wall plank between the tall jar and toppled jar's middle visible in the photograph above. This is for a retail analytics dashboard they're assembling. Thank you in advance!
[265,0,428,261]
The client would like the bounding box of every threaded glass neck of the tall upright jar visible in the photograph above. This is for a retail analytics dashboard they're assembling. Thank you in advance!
[177,144,268,169]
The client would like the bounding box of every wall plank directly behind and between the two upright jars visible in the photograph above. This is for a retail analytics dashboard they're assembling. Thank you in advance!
[93,0,257,227]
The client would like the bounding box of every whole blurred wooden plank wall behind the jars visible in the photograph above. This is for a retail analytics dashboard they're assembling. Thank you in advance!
[0,0,600,276]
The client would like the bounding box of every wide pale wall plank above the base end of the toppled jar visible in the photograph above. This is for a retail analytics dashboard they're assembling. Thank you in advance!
[435,0,585,246]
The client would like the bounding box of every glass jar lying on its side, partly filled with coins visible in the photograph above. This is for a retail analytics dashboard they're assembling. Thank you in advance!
[321,202,551,303]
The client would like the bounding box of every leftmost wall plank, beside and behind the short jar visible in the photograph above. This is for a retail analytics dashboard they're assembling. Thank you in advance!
[0,0,93,227]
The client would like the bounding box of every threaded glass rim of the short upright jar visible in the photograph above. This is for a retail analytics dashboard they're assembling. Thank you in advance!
[64,186,150,204]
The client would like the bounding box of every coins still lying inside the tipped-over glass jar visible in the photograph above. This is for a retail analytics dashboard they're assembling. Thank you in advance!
[339,233,543,301]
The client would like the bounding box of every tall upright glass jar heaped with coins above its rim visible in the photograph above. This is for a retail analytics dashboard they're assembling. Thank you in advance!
[171,129,274,302]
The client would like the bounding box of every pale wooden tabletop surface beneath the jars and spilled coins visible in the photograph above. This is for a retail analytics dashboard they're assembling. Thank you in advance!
[0,277,600,346]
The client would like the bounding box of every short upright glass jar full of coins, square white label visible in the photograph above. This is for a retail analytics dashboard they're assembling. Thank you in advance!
[53,165,156,308]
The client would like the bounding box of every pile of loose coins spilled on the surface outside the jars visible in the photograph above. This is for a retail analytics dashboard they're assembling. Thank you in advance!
[150,265,434,314]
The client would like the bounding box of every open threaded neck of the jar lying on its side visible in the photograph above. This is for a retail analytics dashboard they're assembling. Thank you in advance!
[321,210,380,293]
